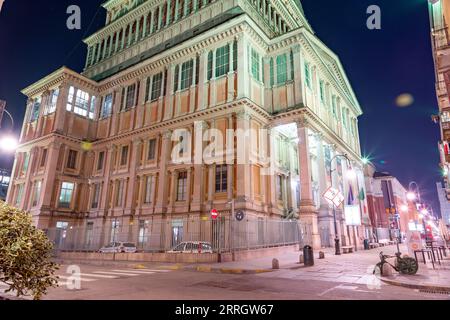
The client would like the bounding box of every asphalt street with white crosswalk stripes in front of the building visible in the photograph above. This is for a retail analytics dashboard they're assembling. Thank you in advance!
[14,265,442,300]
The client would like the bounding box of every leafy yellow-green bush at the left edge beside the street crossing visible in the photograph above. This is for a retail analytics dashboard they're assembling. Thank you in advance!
[0,201,58,300]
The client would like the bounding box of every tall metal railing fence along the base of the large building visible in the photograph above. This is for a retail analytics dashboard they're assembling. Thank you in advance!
[46,218,312,253]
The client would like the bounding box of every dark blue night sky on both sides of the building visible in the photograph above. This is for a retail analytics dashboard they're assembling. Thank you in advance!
[0,0,441,212]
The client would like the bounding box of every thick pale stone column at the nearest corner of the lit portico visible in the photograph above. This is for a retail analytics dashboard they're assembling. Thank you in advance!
[297,119,321,249]
